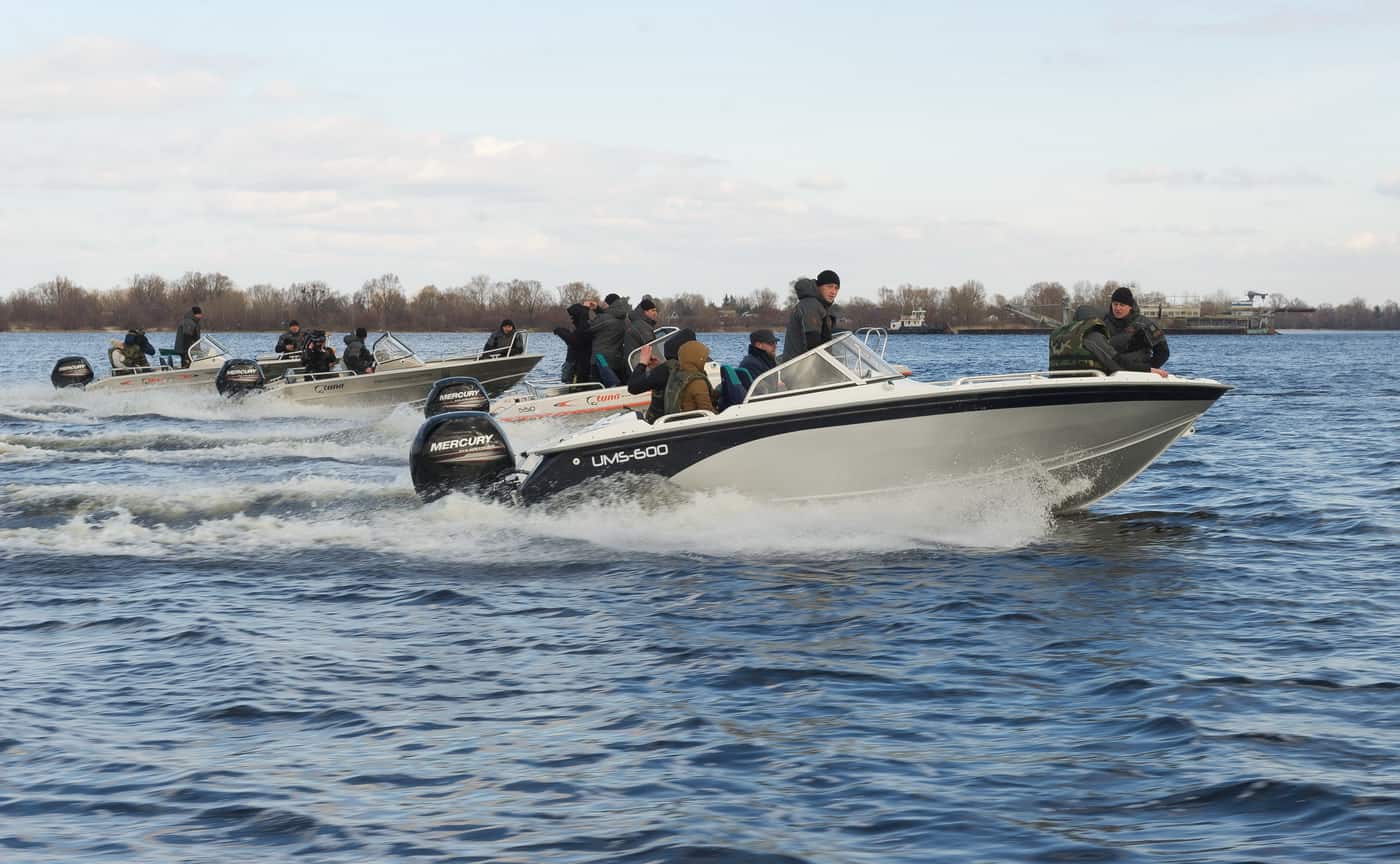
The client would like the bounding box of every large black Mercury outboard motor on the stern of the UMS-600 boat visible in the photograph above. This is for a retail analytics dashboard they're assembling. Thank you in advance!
[409,412,515,501]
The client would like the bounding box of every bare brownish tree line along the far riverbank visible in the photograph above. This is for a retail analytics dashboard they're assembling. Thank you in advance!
[0,272,1400,332]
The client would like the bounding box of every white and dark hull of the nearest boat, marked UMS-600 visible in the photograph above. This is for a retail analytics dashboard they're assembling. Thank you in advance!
[522,375,1229,510]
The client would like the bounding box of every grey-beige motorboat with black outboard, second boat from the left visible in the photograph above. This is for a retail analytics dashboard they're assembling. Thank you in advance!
[220,330,542,405]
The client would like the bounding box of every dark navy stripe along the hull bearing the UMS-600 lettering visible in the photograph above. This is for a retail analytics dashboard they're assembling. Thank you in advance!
[521,384,1229,501]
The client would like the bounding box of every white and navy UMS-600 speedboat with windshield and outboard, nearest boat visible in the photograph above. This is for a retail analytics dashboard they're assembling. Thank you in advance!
[409,333,1231,510]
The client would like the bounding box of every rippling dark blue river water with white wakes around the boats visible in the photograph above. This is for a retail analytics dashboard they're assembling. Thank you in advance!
[0,326,1400,864]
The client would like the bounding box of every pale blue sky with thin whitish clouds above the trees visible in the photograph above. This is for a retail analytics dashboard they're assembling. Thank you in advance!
[0,0,1400,302]
